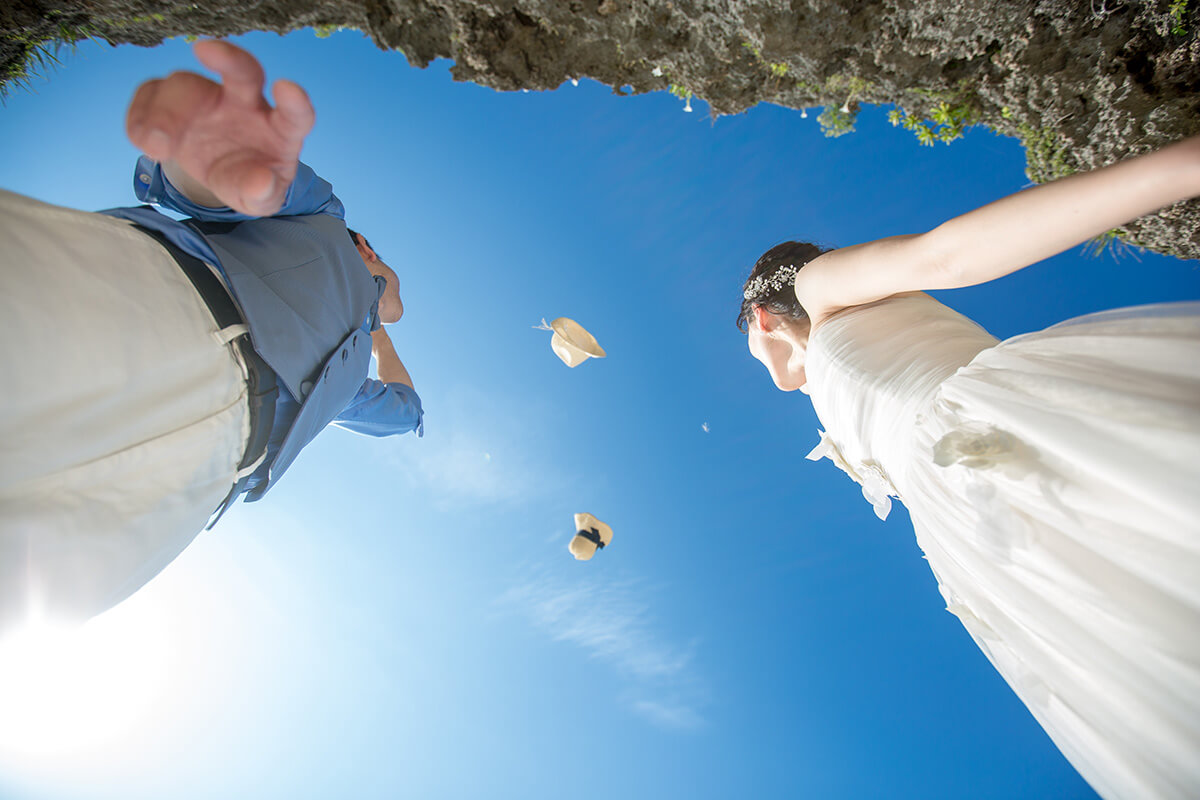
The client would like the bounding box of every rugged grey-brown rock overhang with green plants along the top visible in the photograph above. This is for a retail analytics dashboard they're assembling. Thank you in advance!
[0,0,1200,258]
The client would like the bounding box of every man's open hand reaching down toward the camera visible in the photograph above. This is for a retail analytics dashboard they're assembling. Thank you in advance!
[125,40,316,216]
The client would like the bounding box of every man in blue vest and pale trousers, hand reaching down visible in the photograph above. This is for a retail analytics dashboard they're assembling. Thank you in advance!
[0,41,422,632]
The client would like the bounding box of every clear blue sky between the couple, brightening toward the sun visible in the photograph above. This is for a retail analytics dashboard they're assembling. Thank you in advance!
[0,32,1200,800]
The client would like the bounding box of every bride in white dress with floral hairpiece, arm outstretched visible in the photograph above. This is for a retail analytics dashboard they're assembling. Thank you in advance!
[738,137,1200,800]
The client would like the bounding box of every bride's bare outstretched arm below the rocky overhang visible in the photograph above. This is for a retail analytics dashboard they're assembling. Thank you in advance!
[796,137,1200,323]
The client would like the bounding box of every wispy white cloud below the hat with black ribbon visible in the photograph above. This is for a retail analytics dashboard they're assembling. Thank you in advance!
[499,566,703,729]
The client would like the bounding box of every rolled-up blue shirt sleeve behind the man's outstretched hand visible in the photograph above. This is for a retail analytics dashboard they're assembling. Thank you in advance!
[133,156,346,222]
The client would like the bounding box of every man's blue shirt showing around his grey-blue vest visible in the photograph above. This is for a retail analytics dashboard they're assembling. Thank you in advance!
[101,156,425,491]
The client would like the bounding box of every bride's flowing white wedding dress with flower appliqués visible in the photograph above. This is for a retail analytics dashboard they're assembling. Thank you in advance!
[806,294,1200,800]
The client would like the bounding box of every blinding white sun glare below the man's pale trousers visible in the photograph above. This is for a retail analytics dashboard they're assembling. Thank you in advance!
[0,606,169,757]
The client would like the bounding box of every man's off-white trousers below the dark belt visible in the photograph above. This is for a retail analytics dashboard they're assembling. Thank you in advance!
[0,190,250,634]
